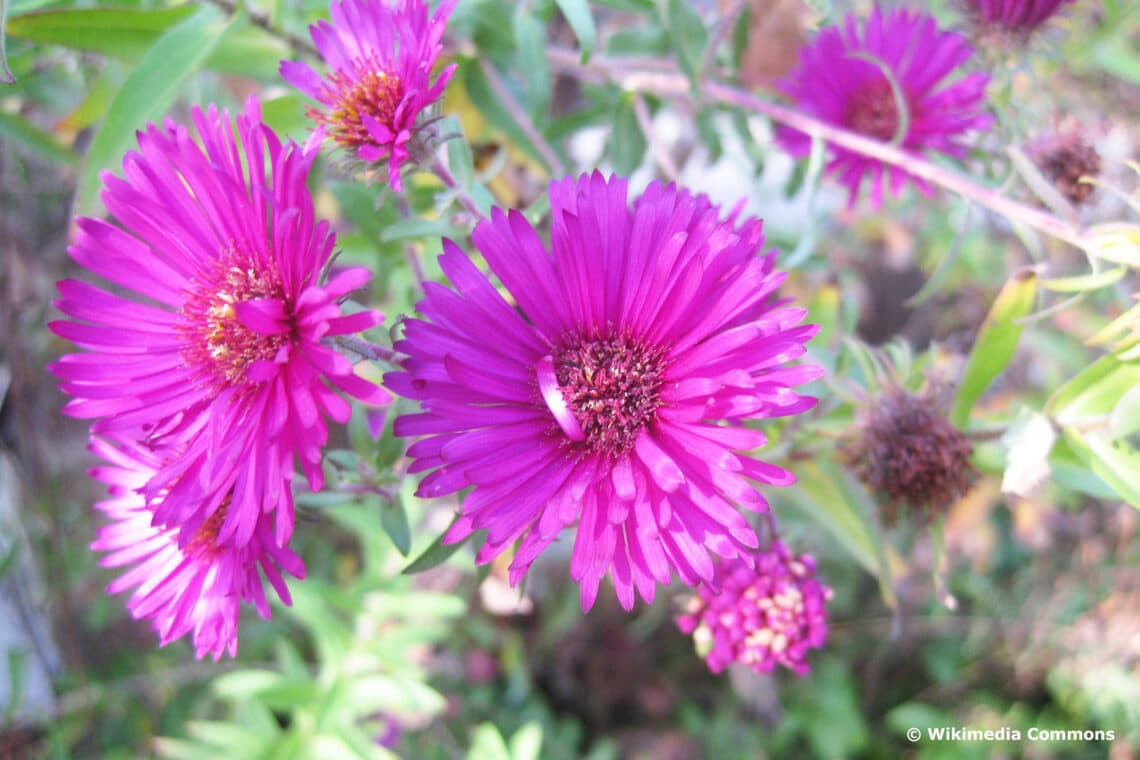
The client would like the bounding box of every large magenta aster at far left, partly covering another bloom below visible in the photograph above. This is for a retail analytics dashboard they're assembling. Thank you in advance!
[50,99,388,553]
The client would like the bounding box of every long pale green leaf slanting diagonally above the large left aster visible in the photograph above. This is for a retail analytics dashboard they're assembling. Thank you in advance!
[76,6,228,214]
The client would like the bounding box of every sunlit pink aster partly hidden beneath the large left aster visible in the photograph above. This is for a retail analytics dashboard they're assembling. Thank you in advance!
[90,436,304,660]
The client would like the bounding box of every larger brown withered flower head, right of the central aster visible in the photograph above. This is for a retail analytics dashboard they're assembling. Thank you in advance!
[842,384,975,524]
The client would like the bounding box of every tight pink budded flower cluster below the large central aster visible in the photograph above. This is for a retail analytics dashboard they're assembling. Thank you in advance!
[677,540,831,676]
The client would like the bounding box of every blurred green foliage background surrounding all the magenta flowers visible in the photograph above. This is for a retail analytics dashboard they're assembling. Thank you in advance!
[0,0,1140,760]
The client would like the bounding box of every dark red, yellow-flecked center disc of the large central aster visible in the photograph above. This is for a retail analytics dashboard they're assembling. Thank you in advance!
[554,335,665,458]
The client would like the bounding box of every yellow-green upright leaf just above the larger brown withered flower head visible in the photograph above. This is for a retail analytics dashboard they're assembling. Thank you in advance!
[950,271,1037,427]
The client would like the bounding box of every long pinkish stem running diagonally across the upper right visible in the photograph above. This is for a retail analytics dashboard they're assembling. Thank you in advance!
[546,48,1084,247]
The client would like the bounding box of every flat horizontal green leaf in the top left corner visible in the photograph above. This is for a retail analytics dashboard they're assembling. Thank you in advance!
[8,3,195,60]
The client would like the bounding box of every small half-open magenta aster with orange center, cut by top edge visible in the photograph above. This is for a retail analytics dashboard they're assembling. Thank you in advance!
[280,0,456,190]
